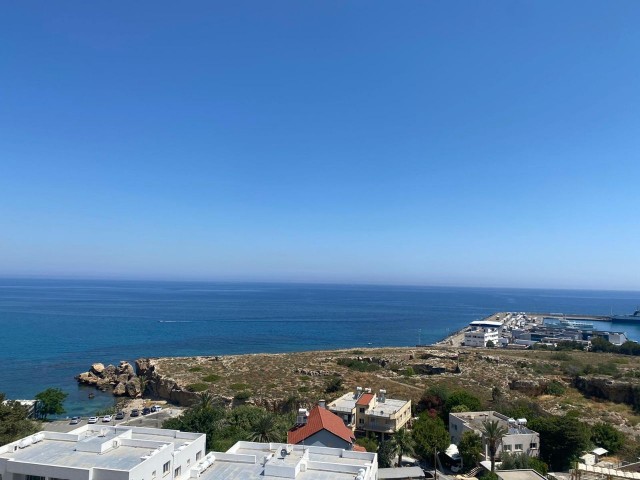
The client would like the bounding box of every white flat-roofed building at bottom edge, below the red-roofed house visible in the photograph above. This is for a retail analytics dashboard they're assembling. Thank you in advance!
[198,442,378,480]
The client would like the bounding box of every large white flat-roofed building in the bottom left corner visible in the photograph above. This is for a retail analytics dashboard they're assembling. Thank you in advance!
[0,425,206,480]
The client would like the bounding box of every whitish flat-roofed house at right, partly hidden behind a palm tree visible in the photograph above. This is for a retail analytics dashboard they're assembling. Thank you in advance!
[449,411,540,458]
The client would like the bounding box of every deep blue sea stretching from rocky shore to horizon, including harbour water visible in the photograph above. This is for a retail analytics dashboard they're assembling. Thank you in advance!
[0,279,640,415]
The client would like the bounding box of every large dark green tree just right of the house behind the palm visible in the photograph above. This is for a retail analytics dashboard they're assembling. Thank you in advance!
[529,413,591,471]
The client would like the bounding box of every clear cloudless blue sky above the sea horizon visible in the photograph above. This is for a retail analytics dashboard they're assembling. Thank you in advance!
[0,0,640,290]
